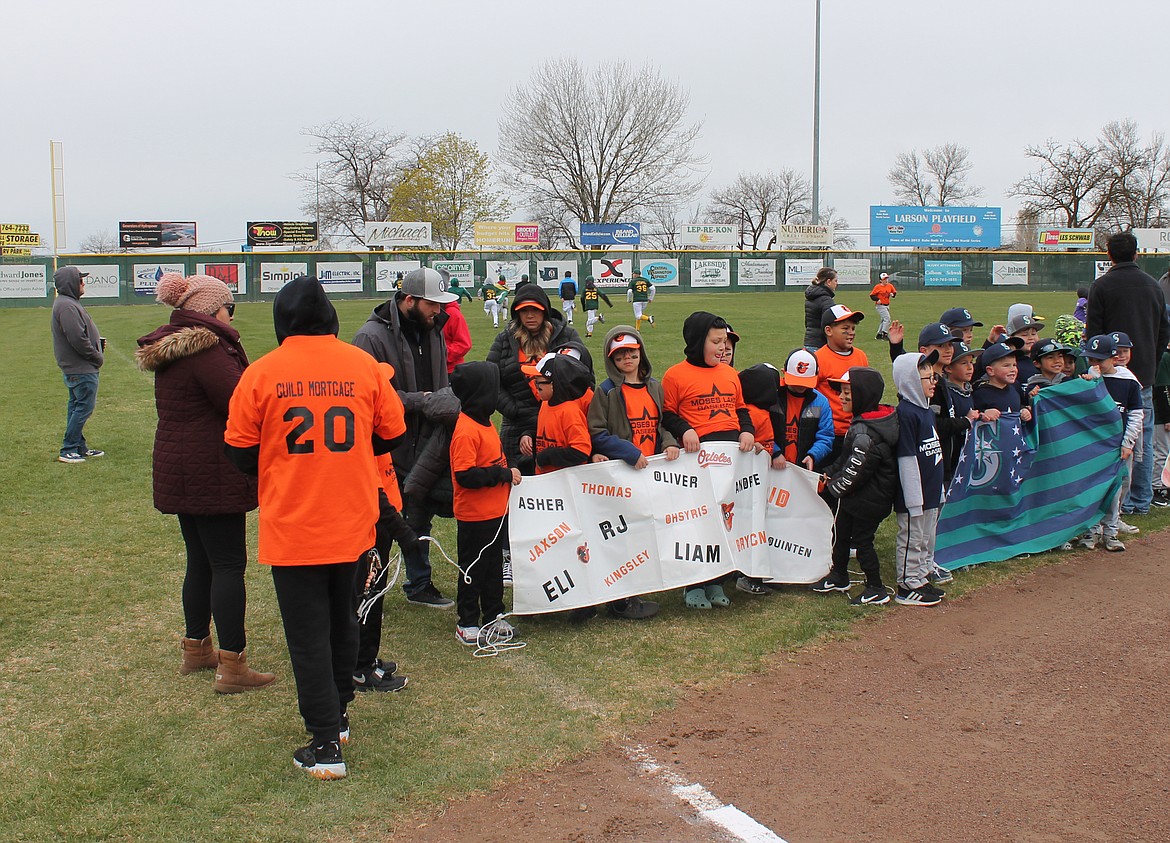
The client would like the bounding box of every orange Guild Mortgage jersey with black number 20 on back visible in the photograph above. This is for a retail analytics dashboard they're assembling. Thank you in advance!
[223,336,402,565]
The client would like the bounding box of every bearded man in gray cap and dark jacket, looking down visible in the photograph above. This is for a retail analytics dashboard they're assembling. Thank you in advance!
[353,267,459,609]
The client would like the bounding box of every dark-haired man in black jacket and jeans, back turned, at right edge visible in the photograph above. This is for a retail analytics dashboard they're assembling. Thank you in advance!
[1085,232,1170,514]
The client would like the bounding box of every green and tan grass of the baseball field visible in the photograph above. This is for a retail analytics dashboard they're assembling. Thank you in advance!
[0,288,1168,843]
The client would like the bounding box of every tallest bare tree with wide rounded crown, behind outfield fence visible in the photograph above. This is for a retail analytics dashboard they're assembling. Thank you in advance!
[498,58,703,236]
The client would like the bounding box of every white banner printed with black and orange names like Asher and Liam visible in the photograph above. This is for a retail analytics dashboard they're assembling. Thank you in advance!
[508,442,833,615]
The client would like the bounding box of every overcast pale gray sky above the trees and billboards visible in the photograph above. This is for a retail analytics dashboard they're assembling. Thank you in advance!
[0,0,1170,248]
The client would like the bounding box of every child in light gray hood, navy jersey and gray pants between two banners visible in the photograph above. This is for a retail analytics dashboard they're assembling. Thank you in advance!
[894,352,944,606]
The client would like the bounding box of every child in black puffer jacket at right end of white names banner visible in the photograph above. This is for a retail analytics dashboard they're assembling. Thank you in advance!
[812,366,898,606]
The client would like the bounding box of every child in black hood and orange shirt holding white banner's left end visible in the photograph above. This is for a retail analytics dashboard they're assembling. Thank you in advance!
[450,360,521,647]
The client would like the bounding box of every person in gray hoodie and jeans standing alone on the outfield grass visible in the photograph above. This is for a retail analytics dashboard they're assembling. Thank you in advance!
[50,267,105,463]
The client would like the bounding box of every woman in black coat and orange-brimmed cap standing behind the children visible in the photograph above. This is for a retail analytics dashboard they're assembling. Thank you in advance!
[488,284,580,475]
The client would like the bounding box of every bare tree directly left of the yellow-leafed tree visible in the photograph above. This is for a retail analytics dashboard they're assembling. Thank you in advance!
[293,119,411,242]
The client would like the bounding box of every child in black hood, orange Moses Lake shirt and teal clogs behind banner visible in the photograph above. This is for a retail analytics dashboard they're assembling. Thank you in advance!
[662,311,756,609]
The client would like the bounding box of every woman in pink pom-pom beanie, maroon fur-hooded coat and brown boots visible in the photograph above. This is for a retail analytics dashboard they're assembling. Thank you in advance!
[135,272,276,693]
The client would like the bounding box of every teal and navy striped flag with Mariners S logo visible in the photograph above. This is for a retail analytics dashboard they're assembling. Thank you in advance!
[935,379,1123,571]
